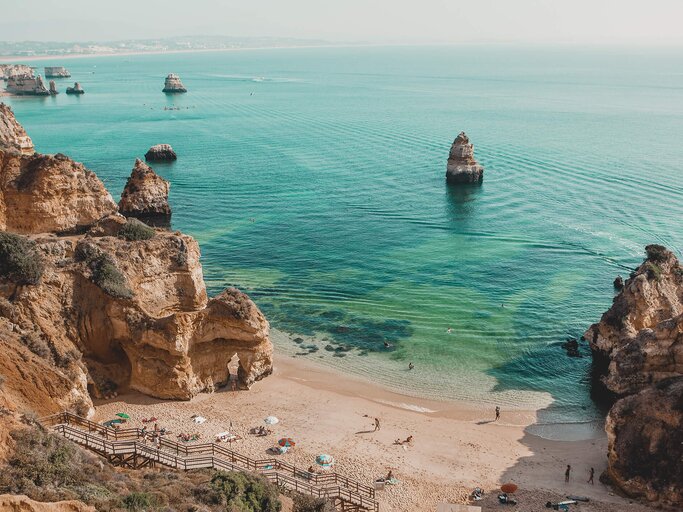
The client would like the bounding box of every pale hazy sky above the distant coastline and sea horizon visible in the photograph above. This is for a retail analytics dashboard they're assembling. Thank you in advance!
[0,0,683,44]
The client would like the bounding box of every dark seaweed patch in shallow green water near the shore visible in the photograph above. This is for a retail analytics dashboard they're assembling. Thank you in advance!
[254,302,413,353]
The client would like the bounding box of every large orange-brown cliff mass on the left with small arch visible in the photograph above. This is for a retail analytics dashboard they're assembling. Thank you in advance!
[0,103,272,415]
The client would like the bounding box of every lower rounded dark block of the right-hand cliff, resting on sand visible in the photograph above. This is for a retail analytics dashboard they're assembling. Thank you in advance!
[603,376,683,510]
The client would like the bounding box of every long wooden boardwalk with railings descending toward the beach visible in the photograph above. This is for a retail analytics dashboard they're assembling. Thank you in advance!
[41,412,379,512]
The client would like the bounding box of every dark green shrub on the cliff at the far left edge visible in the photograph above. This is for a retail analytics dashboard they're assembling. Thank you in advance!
[0,232,45,284]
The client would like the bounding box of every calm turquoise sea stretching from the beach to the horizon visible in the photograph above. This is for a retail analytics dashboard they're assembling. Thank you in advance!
[9,46,683,421]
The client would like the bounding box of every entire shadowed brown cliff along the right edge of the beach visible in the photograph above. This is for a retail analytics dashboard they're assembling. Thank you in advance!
[584,245,683,507]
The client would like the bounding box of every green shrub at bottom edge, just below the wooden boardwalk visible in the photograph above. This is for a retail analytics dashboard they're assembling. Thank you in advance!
[209,471,282,512]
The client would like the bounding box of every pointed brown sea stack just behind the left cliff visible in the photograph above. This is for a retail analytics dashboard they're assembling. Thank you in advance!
[119,159,171,226]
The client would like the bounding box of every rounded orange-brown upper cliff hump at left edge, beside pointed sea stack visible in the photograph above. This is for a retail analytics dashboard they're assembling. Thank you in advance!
[0,150,117,233]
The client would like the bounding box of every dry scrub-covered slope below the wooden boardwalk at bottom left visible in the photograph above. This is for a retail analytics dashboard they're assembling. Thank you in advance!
[0,426,292,512]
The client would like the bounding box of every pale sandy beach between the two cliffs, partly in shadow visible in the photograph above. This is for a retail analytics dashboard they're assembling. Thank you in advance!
[95,355,641,511]
